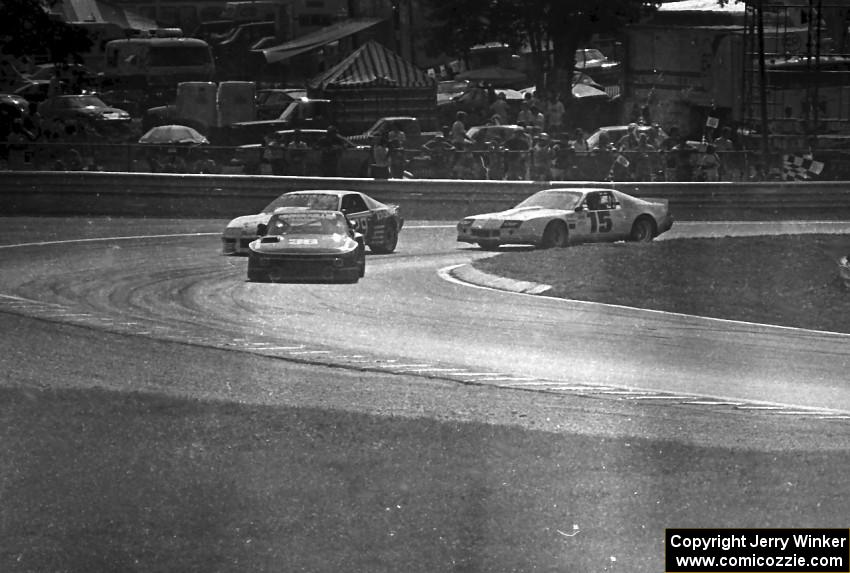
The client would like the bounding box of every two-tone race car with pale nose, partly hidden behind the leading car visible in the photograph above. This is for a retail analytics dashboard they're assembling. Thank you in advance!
[221,190,404,255]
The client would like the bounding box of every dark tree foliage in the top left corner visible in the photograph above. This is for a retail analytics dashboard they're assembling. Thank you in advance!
[0,0,91,62]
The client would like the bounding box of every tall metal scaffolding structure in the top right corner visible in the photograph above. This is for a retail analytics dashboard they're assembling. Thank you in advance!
[740,0,850,150]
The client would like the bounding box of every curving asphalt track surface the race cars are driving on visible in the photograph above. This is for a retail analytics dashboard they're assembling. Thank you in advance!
[0,220,850,420]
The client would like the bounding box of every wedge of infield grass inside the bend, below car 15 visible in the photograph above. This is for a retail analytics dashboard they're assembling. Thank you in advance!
[474,235,850,333]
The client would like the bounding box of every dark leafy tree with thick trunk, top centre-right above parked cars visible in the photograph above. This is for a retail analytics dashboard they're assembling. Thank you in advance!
[425,0,659,92]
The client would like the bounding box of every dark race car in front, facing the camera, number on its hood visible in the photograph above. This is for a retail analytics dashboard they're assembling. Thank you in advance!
[248,210,366,282]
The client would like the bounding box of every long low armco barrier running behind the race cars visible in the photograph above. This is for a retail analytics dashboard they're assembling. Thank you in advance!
[0,171,850,220]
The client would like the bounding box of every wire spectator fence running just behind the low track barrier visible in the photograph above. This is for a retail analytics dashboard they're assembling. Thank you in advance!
[0,141,850,182]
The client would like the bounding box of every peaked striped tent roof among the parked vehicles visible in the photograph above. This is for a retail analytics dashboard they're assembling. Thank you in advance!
[310,41,436,90]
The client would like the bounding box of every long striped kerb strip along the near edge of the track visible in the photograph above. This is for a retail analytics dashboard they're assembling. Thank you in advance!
[0,294,850,422]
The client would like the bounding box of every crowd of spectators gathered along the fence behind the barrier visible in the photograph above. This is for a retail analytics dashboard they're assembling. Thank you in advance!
[0,71,753,181]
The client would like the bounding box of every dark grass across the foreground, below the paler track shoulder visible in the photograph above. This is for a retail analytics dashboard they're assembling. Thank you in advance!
[0,389,850,573]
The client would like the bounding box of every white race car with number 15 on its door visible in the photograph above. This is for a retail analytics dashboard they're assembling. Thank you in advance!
[457,187,673,249]
